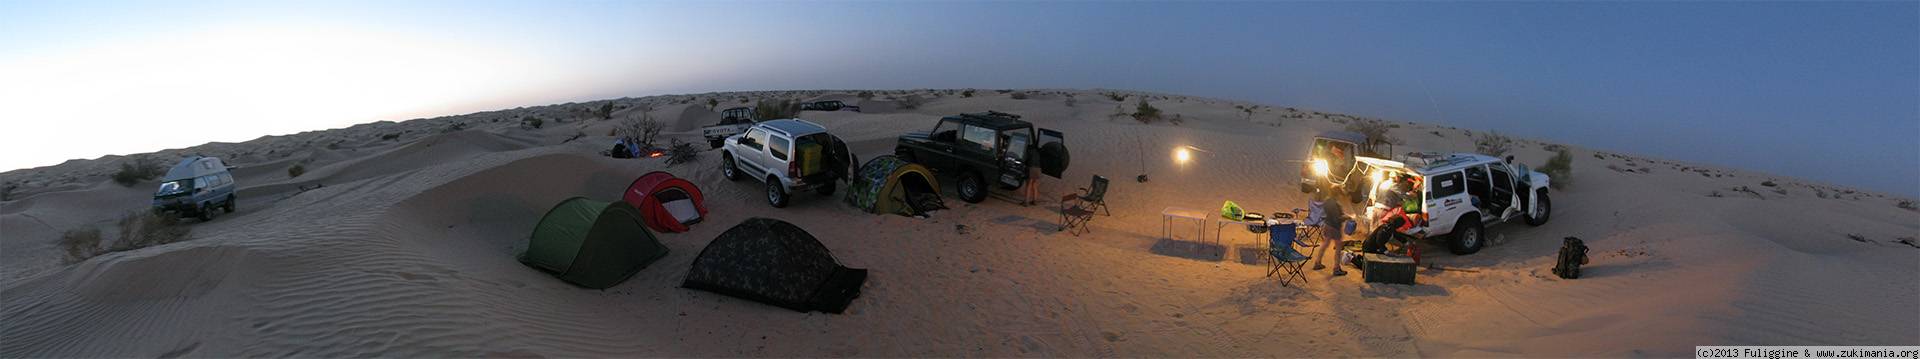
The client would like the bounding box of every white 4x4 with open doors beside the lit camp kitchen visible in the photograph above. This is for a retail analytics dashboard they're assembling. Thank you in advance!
[1359,154,1553,255]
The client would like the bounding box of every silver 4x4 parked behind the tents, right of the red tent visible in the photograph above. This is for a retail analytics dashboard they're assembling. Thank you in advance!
[720,119,858,207]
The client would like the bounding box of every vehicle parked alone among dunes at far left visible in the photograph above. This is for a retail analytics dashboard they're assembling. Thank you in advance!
[154,156,236,221]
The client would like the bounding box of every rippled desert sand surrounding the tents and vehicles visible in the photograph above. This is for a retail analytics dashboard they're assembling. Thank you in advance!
[0,90,1920,357]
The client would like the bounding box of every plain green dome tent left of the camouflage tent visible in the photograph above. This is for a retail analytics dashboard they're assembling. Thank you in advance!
[520,198,666,290]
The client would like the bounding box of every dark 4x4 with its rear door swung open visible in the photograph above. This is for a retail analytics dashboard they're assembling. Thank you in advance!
[893,111,1071,203]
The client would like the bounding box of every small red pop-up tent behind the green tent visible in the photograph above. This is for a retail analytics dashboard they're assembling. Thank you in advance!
[622,171,707,232]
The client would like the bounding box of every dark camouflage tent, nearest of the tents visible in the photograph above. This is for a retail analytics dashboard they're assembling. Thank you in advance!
[680,217,866,313]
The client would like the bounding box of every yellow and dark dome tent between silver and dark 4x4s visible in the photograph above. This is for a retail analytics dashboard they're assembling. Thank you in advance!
[847,156,947,215]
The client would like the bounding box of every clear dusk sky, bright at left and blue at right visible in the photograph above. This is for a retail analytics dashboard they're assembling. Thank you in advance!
[0,0,1920,196]
